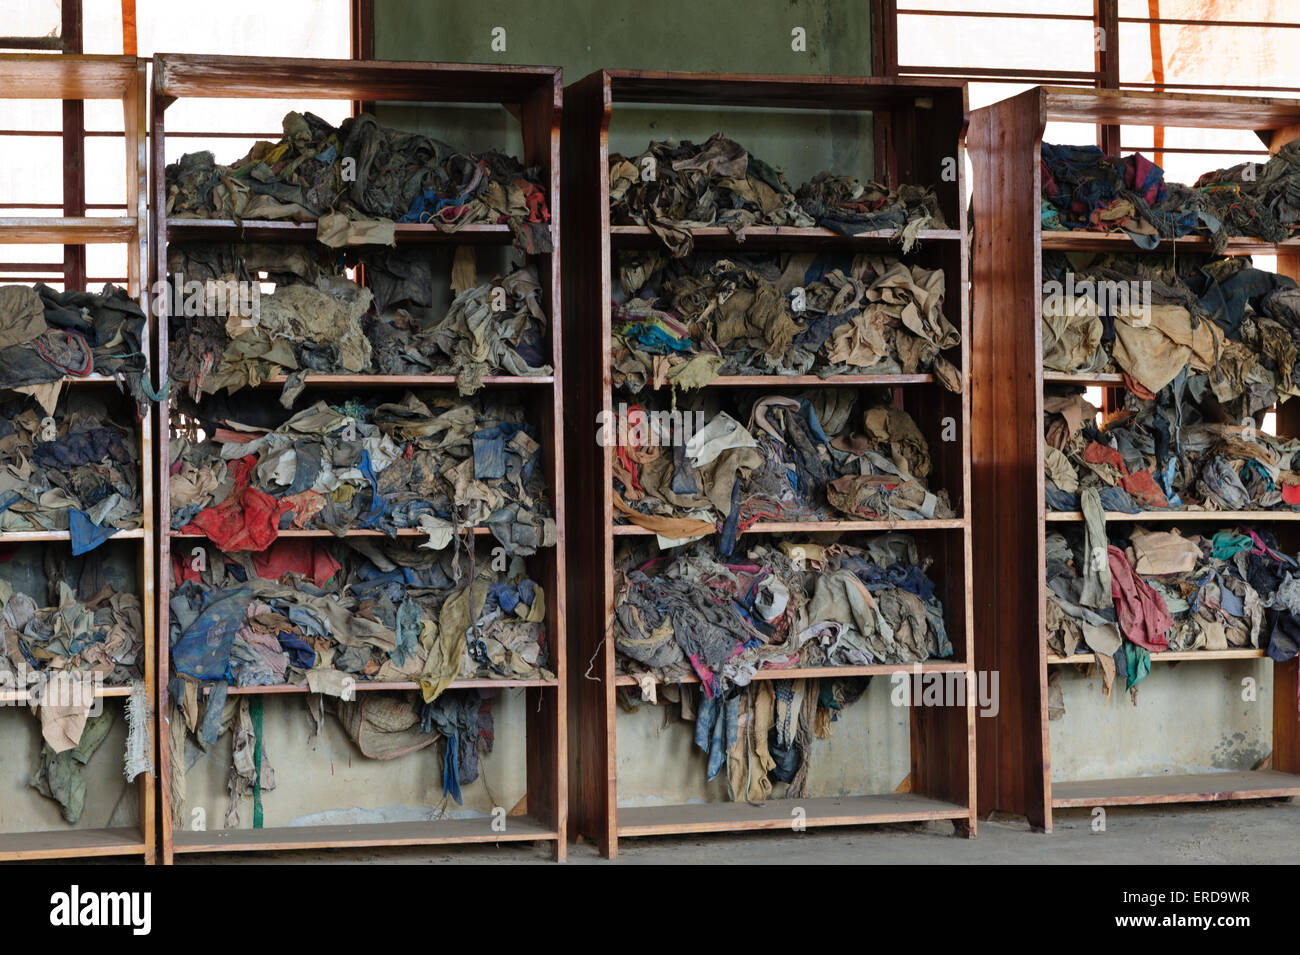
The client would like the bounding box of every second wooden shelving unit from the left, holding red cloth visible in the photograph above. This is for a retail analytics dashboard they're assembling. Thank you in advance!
[151,53,568,863]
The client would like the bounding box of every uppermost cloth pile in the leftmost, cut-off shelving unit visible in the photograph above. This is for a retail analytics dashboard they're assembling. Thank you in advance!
[0,283,152,417]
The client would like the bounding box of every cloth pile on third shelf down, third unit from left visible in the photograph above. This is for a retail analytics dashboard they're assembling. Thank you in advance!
[611,388,954,556]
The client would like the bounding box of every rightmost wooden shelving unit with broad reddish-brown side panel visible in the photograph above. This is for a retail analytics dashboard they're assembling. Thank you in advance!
[969,87,1300,830]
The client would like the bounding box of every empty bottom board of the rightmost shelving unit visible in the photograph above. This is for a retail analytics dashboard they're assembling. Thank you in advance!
[1052,769,1300,809]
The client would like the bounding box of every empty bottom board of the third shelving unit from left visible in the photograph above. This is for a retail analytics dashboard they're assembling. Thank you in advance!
[619,793,970,838]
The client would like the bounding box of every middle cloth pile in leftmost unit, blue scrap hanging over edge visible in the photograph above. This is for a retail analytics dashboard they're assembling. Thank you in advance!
[0,395,140,556]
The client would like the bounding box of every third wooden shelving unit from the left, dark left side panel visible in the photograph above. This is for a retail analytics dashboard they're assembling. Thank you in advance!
[564,70,975,858]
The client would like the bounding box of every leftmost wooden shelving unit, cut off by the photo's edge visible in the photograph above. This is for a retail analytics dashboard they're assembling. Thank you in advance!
[0,53,157,863]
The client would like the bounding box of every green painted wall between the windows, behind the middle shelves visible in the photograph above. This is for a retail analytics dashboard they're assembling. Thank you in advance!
[374,0,874,187]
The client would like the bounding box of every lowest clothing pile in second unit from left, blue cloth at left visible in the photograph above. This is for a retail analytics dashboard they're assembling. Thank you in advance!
[169,538,553,706]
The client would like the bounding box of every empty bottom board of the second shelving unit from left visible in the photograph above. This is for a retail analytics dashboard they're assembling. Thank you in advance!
[173,816,559,854]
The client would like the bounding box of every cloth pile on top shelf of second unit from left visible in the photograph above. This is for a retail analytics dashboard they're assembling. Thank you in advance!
[165,113,551,253]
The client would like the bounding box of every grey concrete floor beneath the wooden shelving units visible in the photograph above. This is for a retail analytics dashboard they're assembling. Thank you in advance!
[177,800,1300,865]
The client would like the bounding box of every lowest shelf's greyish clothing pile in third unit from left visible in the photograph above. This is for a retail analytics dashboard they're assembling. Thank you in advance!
[614,534,953,699]
